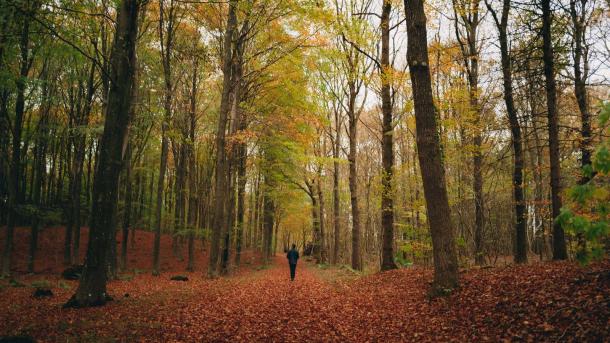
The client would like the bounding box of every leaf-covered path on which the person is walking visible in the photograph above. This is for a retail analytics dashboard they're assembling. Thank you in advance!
[160,257,348,342]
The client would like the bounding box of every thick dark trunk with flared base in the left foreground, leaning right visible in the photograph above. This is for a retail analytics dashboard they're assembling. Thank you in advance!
[65,0,141,307]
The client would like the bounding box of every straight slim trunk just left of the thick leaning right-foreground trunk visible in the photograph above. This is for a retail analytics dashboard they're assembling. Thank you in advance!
[380,1,396,270]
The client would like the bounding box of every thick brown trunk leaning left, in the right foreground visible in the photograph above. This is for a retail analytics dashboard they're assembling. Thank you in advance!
[404,0,458,294]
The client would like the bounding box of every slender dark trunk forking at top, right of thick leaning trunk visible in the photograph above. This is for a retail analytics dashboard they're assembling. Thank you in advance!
[486,0,527,263]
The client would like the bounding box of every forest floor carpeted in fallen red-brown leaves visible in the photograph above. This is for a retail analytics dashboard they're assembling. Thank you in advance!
[0,230,610,342]
